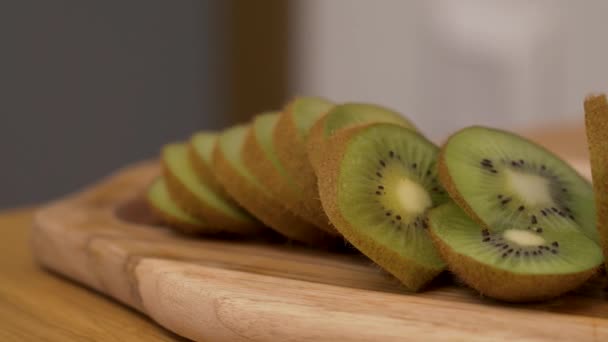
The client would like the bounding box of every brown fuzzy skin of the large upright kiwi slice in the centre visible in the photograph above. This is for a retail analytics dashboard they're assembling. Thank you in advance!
[317,123,443,291]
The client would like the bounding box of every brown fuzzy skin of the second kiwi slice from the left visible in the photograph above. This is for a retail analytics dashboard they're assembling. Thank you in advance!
[161,161,266,236]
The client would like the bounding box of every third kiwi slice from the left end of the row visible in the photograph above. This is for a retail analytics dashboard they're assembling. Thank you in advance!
[188,131,229,197]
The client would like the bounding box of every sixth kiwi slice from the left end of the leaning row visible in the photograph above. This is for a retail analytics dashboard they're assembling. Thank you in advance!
[272,97,336,232]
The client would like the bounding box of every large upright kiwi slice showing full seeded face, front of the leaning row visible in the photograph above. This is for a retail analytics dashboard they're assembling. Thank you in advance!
[317,123,449,291]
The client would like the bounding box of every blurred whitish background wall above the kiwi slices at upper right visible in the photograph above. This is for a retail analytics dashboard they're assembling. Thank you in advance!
[290,0,608,141]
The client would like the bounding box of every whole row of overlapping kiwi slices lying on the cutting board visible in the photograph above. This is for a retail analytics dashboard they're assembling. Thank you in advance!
[147,93,608,302]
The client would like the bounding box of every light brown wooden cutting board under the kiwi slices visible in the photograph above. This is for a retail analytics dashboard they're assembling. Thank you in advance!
[31,163,608,341]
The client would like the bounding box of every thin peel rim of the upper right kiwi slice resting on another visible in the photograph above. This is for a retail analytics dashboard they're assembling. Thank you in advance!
[437,126,586,235]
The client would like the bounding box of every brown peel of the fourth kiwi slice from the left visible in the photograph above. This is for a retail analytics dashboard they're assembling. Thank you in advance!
[213,126,335,248]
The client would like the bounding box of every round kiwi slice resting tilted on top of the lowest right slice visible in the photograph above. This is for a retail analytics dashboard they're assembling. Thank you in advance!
[439,127,598,241]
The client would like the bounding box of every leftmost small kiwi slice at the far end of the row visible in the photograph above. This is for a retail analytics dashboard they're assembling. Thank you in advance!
[146,177,210,234]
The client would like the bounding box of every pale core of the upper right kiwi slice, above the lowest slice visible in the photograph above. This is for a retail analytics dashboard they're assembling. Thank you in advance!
[506,170,553,207]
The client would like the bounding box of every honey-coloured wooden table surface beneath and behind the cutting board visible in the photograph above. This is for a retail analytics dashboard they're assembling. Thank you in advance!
[0,123,588,341]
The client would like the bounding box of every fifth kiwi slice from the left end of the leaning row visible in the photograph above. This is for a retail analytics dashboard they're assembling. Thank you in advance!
[242,112,338,235]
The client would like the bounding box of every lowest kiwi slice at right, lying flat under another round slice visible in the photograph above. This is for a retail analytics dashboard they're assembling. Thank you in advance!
[429,203,602,302]
